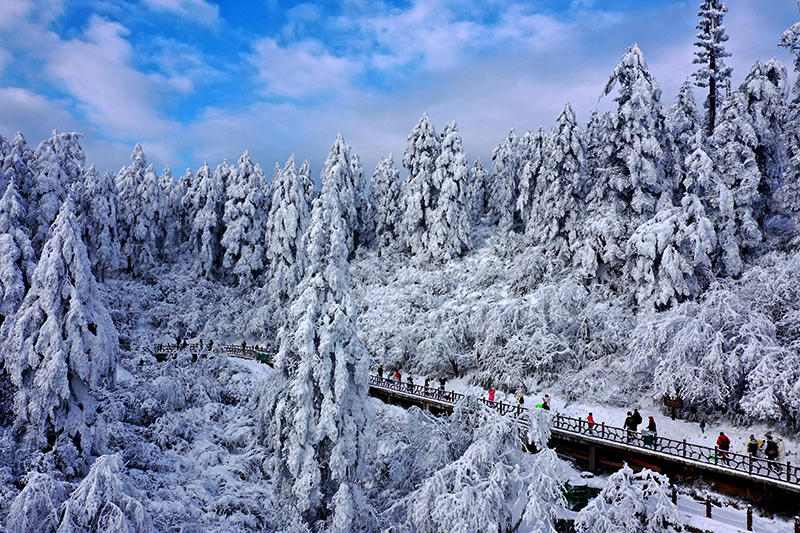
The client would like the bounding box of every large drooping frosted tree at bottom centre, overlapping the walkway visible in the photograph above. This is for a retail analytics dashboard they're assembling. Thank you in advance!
[384,398,565,532]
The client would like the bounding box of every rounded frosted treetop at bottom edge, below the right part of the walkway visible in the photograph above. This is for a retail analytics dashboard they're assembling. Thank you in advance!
[575,464,683,533]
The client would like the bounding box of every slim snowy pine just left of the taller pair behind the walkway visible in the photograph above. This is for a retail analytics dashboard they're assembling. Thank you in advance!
[367,154,403,253]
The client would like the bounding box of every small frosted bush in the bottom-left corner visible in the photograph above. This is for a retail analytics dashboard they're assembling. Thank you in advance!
[5,472,71,533]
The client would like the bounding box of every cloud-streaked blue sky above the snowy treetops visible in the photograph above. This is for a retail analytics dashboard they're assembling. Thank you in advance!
[0,0,800,176]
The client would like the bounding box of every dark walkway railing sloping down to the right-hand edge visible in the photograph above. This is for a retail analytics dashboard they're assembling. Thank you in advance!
[369,375,800,488]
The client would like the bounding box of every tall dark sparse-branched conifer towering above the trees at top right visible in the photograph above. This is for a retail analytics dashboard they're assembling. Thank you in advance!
[692,0,733,137]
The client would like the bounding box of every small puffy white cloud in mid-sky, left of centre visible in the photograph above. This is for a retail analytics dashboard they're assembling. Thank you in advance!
[250,38,361,98]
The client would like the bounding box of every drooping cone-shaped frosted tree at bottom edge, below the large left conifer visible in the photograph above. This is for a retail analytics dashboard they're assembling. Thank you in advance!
[57,454,156,533]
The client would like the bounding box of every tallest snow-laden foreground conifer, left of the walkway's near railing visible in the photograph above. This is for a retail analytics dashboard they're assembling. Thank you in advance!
[259,152,372,532]
